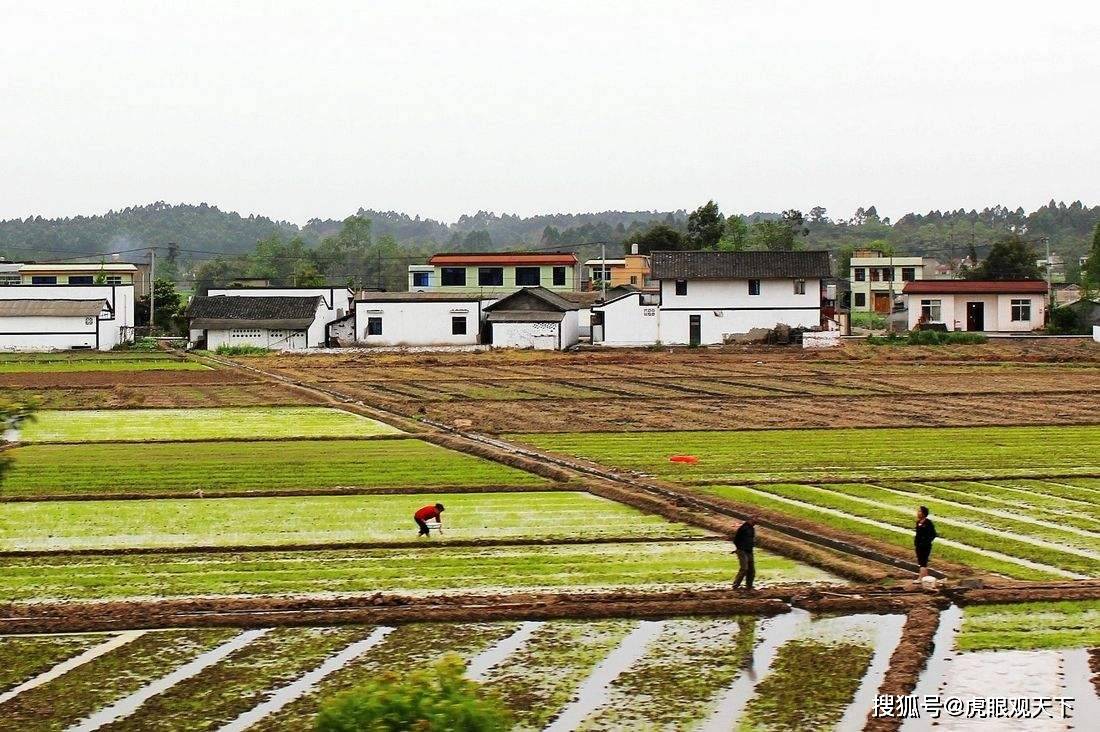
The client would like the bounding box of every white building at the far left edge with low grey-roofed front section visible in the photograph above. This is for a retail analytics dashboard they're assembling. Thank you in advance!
[0,284,134,351]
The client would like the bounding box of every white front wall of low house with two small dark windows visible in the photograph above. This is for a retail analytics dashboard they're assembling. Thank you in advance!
[355,301,481,346]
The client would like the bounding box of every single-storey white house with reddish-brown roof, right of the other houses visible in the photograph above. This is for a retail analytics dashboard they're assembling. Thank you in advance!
[903,280,1047,332]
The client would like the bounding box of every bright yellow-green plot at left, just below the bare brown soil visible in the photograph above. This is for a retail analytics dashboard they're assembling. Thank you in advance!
[20,406,400,443]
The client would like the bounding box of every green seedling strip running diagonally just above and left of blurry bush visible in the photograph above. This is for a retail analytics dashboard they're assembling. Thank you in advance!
[251,623,515,732]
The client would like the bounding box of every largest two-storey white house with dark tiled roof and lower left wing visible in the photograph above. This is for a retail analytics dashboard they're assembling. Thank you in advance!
[592,251,829,347]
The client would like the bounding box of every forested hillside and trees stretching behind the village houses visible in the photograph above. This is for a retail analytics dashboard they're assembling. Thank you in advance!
[0,200,1100,288]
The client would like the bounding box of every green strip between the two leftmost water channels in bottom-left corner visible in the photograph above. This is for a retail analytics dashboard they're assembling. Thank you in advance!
[0,629,238,732]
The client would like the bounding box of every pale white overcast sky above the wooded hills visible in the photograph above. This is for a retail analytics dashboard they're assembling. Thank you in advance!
[0,0,1100,223]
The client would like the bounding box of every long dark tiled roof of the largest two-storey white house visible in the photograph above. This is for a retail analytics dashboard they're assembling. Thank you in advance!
[650,251,829,280]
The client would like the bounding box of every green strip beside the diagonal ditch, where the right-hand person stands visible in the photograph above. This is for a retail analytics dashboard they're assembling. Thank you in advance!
[702,485,1059,580]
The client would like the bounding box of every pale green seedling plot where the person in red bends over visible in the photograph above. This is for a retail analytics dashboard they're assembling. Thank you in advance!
[0,491,706,550]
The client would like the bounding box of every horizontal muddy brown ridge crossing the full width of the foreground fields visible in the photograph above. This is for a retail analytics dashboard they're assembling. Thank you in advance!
[0,581,1100,634]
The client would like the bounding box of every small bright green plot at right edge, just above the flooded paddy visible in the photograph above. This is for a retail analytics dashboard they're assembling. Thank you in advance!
[955,600,1100,651]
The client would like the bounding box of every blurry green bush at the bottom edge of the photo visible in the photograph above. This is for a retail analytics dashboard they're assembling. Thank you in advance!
[316,656,512,732]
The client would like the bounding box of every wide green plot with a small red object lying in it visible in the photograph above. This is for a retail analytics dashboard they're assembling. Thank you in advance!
[510,425,1100,482]
